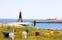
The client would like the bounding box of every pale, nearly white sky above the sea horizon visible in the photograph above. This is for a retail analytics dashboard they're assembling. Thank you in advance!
[0,0,62,19]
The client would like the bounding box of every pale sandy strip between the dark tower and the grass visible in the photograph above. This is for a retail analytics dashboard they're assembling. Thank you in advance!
[0,22,32,27]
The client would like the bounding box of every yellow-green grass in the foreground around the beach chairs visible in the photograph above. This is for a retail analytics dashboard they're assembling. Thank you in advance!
[0,27,62,40]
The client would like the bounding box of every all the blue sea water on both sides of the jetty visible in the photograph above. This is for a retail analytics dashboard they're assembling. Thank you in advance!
[0,19,62,30]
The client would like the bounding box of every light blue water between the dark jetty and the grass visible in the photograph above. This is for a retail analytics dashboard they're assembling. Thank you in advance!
[30,23,62,30]
